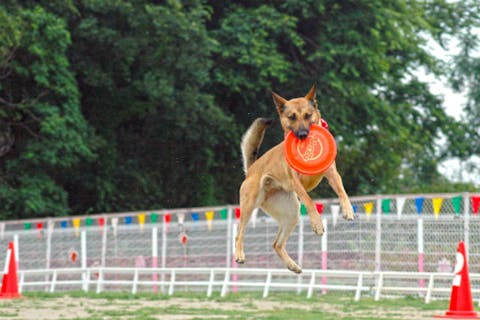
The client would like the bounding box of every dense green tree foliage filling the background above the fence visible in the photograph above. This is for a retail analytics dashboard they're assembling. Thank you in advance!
[0,0,480,217]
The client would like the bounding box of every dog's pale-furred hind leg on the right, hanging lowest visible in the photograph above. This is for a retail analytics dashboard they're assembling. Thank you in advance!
[262,190,302,273]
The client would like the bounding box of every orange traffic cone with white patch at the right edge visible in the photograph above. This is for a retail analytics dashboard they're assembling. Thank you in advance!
[435,241,480,319]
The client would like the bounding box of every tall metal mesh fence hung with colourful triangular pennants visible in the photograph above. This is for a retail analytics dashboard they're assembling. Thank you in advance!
[0,193,480,282]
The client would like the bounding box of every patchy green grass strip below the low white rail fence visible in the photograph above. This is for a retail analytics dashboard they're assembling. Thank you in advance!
[0,292,448,320]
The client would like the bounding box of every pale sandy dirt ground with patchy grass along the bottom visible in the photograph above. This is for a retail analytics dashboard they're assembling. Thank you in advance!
[0,296,443,320]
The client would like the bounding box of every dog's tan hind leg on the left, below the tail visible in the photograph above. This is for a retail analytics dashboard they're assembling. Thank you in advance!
[235,179,261,263]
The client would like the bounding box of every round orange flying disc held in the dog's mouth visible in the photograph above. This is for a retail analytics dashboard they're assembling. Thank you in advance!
[284,124,337,175]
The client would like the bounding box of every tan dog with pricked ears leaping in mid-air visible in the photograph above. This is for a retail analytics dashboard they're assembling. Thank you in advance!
[235,85,354,273]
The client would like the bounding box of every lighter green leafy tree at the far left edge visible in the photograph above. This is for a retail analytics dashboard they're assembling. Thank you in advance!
[0,3,94,218]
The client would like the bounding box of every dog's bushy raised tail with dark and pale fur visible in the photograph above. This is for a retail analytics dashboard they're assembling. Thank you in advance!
[240,118,273,173]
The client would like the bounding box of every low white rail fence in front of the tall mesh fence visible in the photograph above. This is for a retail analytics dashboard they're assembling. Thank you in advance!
[5,268,480,303]
